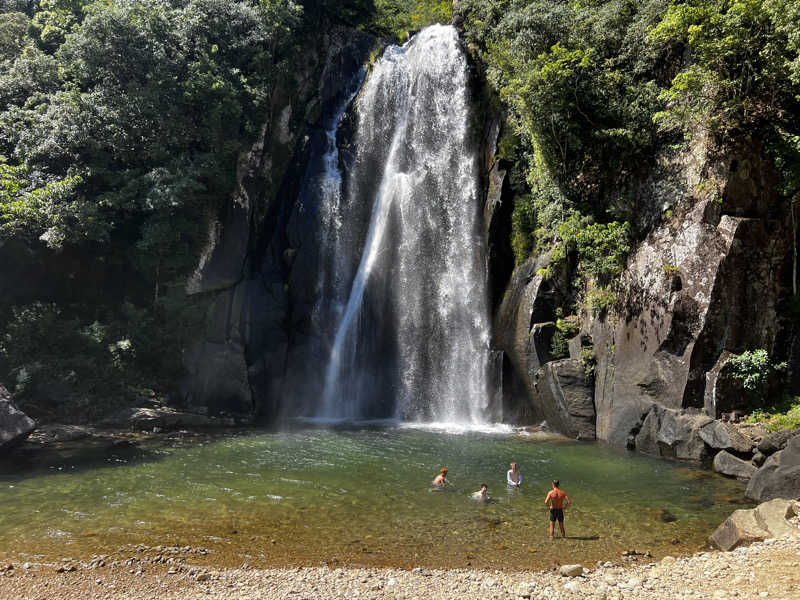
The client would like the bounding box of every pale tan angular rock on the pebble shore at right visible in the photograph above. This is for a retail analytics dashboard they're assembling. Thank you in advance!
[709,499,800,550]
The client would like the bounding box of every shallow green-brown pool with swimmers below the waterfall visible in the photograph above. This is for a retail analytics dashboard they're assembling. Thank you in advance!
[0,426,743,568]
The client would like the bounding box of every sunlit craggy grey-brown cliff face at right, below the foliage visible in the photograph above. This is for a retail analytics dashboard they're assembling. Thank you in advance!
[586,142,791,450]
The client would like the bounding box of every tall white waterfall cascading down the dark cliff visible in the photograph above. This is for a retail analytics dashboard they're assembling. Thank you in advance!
[317,25,489,423]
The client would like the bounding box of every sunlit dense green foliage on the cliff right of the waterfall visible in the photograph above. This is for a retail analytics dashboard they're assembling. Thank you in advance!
[464,0,800,314]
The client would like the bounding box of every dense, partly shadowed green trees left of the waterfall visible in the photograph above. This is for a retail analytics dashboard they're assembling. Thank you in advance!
[0,0,451,417]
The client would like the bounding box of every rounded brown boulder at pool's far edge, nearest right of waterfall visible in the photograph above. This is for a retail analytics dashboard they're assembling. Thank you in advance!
[533,358,595,440]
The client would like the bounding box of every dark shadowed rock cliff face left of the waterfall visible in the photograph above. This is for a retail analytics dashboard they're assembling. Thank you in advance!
[182,30,376,418]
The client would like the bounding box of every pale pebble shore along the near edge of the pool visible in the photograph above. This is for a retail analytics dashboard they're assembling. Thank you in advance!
[0,534,800,600]
